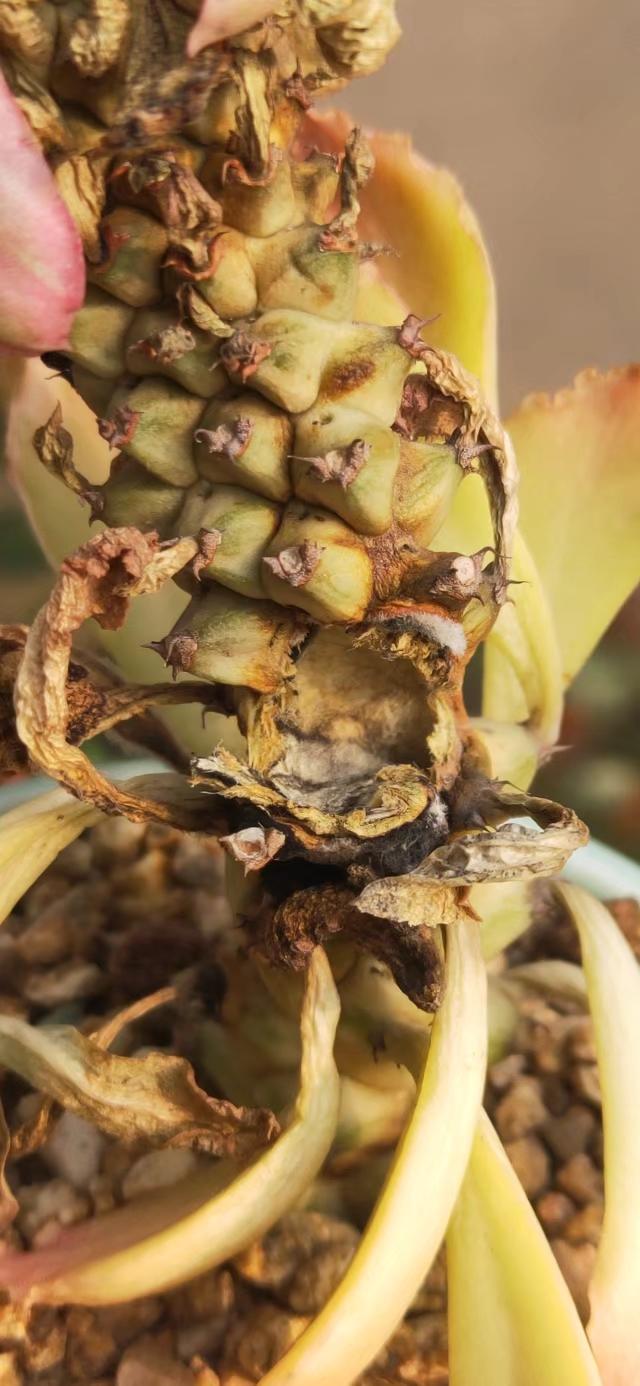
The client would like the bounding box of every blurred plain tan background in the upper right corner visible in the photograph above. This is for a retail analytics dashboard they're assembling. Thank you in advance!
[344,0,640,410]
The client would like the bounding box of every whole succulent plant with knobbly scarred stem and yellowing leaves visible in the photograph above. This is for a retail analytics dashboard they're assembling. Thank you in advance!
[0,0,640,1386]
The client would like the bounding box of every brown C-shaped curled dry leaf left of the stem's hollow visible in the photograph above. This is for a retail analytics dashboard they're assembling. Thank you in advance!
[15,527,224,827]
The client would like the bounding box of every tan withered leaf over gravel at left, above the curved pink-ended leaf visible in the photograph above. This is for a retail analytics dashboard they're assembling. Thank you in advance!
[0,1016,278,1157]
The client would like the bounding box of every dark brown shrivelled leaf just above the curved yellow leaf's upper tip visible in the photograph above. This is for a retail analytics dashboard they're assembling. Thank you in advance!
[263,886,443,1012]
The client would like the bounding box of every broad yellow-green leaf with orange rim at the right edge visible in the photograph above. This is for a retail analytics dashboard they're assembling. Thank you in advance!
[508,366,640,682]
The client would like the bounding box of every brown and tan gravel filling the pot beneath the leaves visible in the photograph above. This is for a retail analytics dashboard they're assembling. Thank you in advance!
[0,819,623,1386]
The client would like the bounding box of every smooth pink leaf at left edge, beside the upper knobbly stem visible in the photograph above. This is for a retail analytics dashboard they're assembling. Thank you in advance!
[0,73,85,356]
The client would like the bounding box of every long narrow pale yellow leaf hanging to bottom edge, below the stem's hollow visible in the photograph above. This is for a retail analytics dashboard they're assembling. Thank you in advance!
[257,923,486,1386]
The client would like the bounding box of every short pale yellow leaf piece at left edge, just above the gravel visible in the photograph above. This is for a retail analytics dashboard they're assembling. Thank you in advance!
[0,790,103,924]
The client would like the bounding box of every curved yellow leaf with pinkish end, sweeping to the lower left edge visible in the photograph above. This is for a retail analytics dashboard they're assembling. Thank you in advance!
[0,948,339,1304]
